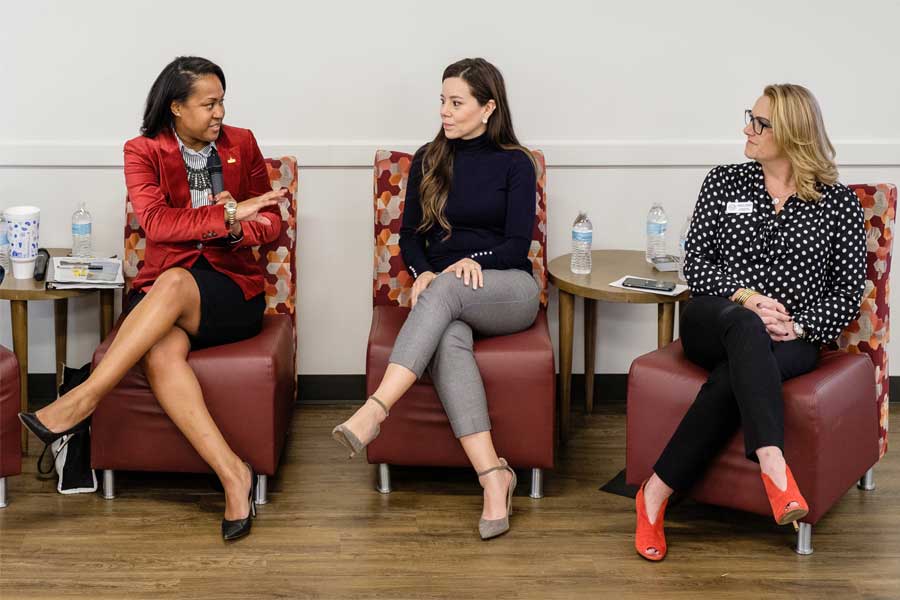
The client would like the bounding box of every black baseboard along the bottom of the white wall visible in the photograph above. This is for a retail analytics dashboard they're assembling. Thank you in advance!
[28,373,900,411]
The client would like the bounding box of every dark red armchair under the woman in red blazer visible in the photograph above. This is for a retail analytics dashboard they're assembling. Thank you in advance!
[91,157,297,504]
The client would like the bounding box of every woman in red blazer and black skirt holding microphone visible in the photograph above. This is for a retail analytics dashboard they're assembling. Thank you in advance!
[20,57,285,540]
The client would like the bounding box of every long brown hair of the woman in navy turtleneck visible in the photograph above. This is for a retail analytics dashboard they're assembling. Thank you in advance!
[418,58,539,239]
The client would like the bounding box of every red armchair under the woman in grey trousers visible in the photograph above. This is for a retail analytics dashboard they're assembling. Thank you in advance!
[366,150,556,498]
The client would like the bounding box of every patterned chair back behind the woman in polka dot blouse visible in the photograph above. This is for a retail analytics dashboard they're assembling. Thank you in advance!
[837,183,897,456]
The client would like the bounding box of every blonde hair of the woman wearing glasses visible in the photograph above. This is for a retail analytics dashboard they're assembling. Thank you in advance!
[763,83,838,200]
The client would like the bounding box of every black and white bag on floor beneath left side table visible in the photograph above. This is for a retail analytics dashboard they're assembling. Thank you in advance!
[38,364,97,494]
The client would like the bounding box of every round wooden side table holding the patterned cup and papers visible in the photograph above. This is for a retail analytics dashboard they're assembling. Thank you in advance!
[0,248,115,453]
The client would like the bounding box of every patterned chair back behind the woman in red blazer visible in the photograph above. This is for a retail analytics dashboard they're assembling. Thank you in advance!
[123,156,297,346]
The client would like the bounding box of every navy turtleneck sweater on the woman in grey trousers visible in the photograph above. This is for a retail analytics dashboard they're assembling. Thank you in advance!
[400,133,537,277]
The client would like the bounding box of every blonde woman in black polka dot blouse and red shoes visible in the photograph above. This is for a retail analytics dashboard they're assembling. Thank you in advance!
[635,84,866,560]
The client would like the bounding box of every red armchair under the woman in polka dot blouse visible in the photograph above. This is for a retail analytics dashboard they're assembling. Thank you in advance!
[626,184,897,554]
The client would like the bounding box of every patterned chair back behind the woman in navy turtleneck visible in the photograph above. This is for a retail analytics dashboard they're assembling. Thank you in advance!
[372,150,547,308]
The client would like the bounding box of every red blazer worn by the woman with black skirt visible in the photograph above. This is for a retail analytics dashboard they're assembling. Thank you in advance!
[125,125,281,299]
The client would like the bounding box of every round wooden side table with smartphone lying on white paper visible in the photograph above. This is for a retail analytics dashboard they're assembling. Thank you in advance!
[548,250,690,442]
